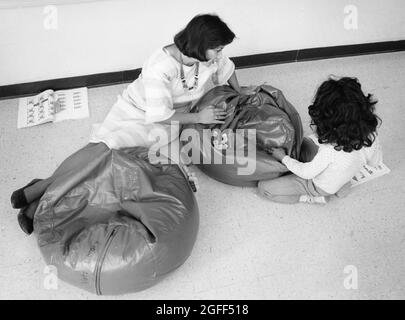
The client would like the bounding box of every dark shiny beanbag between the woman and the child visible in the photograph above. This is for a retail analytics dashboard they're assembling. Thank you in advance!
[180,85,303,186]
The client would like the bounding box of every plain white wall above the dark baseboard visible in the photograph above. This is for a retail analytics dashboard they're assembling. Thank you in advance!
[0,0,405,85]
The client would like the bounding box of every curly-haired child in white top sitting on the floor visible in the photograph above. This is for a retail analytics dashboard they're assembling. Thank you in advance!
[258,77,382,203]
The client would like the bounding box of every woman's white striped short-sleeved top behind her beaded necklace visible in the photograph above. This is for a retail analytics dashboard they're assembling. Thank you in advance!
[122,48,235,123]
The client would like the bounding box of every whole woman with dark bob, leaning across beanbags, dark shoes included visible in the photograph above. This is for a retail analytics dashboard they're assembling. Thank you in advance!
[11,14,246,234]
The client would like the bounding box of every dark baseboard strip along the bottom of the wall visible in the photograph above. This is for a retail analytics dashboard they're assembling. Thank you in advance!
[0,40,405,99]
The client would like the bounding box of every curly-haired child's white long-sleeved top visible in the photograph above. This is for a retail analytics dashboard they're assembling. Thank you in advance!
[282,135,382,194]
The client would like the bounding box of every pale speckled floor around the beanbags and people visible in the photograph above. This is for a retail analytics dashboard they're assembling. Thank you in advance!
[0,52,405,299]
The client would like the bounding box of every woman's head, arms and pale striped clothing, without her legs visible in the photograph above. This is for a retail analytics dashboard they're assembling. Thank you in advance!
[91,14,245,154]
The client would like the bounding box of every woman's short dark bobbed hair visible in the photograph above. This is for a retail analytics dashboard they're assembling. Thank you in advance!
[174,14,235,61]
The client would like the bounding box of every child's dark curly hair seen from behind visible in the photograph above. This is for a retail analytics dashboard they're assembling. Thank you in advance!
[308,77,381,152]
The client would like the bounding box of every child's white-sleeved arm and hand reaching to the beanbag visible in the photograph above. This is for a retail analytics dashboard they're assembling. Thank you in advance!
[272,148,332,179]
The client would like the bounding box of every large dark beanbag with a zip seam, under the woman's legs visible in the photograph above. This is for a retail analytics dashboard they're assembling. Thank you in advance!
[34,144,199,295]
